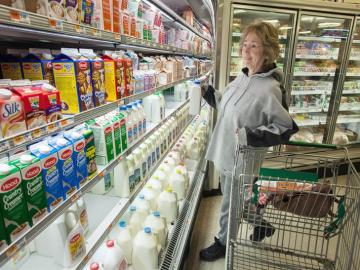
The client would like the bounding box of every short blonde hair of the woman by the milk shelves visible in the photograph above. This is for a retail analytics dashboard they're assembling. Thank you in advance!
[240,22,280,65]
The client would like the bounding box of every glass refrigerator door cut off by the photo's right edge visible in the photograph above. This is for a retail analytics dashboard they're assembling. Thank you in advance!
[333,20,360,144]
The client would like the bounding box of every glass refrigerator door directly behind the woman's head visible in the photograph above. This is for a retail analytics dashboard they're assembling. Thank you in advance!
[228,5,296,82]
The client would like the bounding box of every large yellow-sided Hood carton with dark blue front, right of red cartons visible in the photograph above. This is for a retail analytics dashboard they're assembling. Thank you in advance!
[53,49,94,114]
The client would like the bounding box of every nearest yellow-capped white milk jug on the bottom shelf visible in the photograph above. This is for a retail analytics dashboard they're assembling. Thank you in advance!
[158,187,178,223]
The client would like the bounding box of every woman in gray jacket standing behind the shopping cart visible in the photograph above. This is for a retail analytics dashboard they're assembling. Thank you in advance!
[200,22,298,261]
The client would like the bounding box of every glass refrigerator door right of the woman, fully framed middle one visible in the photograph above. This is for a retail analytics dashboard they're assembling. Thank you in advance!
[289,14,351,143]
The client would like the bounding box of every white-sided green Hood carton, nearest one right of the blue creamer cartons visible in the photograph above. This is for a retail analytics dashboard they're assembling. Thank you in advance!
[89,120,115,165]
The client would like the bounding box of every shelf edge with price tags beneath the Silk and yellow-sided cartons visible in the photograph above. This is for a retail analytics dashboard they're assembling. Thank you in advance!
[0,72,209,158]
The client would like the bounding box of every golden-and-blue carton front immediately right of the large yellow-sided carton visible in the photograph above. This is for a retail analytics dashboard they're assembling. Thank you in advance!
[91,60,106,107]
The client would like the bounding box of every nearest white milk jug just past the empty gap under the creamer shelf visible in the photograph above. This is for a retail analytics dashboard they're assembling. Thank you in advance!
[114,158,130,198]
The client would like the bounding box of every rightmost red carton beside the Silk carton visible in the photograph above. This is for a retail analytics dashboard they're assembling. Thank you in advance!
[32,81,62,123]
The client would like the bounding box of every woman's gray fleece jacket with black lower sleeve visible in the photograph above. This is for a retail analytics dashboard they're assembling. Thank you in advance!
[206,68,298,173]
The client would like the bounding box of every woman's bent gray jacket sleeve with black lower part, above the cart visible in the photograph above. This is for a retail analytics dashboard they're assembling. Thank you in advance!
[238,86,299,147]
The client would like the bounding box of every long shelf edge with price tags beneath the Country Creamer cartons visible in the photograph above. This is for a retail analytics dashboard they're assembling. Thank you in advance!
[0,98,188,269]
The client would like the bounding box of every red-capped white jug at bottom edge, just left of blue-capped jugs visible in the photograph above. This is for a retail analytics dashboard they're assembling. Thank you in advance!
[103,240,127,270]
